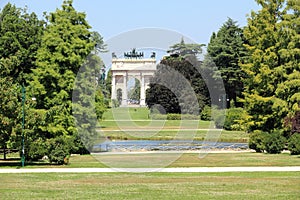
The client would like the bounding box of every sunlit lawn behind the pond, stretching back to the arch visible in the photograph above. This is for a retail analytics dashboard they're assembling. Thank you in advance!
[98,108,249,142]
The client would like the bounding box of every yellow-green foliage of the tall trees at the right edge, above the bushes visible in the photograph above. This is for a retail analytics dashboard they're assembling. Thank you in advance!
[241,0,300,132]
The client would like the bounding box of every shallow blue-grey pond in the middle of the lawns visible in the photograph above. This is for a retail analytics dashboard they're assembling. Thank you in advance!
[93,140,248,152]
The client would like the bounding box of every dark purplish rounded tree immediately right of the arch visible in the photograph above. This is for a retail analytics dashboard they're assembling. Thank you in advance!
[146,40,210,115]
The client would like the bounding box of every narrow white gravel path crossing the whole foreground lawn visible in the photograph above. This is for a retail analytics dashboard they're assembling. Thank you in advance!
[0,166,300,174]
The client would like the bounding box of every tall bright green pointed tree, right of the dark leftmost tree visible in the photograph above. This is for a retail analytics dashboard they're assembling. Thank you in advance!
[30,0,95,159]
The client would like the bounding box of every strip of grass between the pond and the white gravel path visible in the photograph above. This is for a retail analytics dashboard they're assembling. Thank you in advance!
[0,153,300,168]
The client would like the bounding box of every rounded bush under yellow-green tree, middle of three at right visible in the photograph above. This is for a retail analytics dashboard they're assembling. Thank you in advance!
[264,130,286,154]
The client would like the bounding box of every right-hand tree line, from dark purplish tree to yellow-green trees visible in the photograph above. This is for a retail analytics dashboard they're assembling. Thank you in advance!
[146,0,300,154]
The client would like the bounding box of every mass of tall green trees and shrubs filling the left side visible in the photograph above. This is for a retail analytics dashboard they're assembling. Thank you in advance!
[0,0,108,164]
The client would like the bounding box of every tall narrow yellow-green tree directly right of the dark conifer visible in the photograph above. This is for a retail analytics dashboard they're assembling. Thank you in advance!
[241,0,285,132]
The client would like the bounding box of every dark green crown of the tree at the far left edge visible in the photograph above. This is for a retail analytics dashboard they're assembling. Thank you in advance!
[0,3,44,82]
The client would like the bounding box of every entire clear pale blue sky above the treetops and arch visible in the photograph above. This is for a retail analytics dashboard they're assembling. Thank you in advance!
[0,0,259,68]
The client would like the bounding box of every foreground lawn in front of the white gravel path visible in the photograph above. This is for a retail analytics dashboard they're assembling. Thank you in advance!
[0,172,300,200]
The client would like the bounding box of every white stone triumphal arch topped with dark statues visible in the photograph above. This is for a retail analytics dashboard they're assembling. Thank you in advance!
[111,49,156,107]
